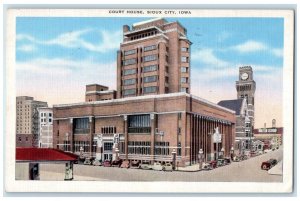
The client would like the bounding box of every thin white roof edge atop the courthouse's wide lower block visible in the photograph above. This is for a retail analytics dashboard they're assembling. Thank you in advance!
[53,92,235,114]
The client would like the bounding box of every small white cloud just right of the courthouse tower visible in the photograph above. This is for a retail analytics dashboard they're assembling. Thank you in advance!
[192,48,229,68]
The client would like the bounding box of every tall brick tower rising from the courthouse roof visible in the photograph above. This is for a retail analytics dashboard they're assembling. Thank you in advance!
[117,19,191,98]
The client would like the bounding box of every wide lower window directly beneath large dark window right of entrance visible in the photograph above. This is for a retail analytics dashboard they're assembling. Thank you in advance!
[128,141,151,155]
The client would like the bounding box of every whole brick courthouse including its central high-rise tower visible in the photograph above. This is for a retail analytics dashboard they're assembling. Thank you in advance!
[53,19,236,166]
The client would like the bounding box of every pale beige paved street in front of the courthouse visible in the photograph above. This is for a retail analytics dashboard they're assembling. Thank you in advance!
[41,149,282,182]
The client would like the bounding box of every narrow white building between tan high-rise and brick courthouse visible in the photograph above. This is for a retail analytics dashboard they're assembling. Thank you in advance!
[38,107,53,148]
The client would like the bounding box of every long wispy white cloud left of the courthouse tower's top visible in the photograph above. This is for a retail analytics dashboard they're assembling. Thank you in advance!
[17,29,122,53]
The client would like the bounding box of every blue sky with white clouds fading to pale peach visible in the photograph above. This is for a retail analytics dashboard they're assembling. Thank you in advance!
[16,17,284,126]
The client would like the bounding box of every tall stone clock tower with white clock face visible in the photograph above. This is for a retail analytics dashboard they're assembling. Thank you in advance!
[236,66,256,130]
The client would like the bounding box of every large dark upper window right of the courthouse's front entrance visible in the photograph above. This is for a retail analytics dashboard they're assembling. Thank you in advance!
[128,114,151,133]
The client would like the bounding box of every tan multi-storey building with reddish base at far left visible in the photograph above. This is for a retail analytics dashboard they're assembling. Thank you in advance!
[16,96,48,147]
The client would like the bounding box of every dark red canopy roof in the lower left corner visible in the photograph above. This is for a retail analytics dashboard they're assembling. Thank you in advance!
[16,147,78,162]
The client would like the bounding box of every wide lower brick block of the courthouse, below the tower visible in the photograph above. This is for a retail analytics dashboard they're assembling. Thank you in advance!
[53,92,235,166]
